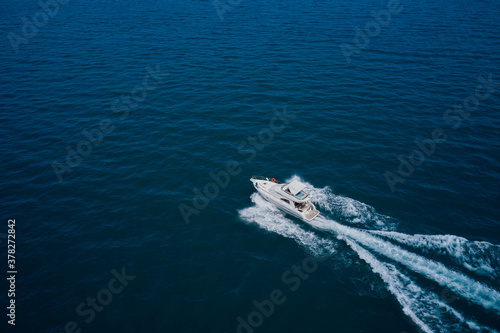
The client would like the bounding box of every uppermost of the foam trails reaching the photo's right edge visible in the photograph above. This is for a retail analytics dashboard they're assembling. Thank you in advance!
[370,231,500,281]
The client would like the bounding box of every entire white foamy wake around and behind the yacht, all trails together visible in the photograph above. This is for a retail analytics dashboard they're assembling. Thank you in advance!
[239,176,500,333]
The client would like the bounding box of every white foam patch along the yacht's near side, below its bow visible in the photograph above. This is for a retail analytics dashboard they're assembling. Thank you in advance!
[239,193,335,256]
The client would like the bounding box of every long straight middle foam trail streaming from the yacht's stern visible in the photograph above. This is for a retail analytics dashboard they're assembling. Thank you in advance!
[310,216,500,313]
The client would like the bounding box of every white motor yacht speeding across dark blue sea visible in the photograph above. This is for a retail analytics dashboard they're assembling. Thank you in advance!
[250,176,319,221]
